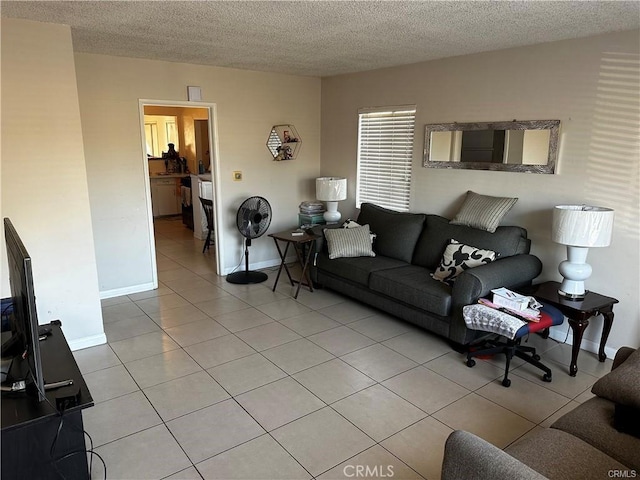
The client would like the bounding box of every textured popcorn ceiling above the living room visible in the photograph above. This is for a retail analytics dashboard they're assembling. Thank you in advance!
[0,0,640,76]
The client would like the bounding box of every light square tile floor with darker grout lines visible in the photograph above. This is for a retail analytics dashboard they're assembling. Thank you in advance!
[74,220,611,480]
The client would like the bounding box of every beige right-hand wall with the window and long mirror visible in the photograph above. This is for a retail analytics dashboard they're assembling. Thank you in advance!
[321,31,640,352]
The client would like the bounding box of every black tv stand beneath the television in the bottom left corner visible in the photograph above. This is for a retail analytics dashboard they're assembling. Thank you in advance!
[0,323,93,480]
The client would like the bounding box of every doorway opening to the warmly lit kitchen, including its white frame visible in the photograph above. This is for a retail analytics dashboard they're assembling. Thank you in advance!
[139,100,224,288]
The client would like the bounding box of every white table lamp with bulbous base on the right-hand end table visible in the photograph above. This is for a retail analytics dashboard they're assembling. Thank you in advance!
[552,205,614,300]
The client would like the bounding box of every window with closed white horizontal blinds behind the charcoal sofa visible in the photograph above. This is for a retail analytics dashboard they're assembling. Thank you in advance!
[356,105,416,212]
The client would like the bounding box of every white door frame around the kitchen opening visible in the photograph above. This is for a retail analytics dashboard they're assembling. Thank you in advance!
[138,99,225,288]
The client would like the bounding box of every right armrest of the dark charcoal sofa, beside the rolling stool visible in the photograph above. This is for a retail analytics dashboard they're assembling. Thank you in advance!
[449,254,542,344]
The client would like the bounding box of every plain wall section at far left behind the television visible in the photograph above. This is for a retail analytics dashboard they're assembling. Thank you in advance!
[1,18,106,349]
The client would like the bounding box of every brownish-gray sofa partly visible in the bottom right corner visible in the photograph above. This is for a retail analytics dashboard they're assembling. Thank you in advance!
[442,347,640,480]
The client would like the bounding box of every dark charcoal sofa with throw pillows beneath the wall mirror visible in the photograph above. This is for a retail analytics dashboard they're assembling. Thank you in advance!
[311,203,542,344]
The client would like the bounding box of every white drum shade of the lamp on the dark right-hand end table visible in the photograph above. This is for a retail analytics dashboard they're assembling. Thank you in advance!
[551,205,614,247]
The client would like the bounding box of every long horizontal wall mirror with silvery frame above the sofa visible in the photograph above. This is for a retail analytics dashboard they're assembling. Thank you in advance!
[423,120,560,173]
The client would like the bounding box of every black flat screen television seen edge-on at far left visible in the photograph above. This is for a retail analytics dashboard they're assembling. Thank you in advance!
[2,218,45,402]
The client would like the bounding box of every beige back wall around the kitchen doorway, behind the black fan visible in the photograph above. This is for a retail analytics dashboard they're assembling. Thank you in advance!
[75,53,321,296]
